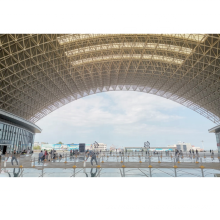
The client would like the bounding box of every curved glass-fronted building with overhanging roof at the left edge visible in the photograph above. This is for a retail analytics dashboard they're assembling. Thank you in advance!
[0,110,41,154]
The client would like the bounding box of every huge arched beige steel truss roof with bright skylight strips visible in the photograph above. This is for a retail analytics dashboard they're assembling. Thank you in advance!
[0,34,220,124]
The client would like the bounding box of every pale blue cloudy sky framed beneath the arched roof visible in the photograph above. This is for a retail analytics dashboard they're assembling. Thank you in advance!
[35,91,217,149]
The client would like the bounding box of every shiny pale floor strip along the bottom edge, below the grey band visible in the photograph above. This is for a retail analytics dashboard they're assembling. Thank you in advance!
[0,168,220,177]
